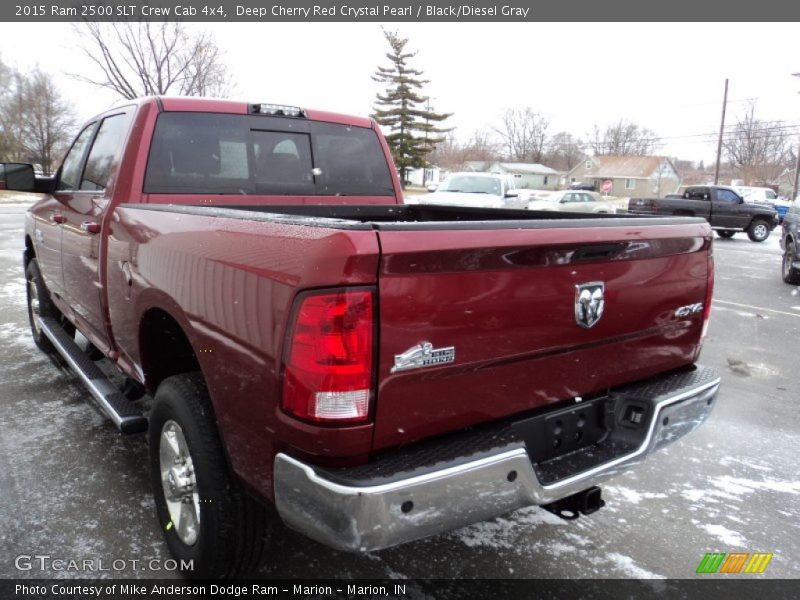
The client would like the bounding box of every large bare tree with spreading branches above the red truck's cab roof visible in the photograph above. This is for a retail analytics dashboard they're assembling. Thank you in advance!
[75,22,231,100]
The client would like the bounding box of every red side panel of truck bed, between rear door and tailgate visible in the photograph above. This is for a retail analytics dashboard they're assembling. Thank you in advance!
[108,206,378,498]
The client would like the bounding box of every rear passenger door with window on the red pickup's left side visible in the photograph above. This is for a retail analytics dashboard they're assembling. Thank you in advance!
[56,109,131,350]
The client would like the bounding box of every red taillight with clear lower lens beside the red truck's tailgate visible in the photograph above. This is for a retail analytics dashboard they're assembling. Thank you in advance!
[281,290,375,423]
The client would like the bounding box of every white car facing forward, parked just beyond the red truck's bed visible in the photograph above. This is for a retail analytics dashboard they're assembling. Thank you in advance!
[406,172,528,208]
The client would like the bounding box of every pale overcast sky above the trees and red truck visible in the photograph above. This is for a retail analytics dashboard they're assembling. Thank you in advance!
[0,23,800,162]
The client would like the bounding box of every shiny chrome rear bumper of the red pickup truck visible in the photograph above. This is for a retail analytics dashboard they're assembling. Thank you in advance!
[274,367,720,552]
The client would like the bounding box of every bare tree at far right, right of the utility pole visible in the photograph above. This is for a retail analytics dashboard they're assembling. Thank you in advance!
[722,102,792,185]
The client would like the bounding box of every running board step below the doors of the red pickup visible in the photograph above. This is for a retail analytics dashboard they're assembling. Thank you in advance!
[39,317,147,433]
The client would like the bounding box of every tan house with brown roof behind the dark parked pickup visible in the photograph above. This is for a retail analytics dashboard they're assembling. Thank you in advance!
[567,156,681,198]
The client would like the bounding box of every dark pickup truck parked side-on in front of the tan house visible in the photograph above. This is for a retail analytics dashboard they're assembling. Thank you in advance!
[628,185,778,242]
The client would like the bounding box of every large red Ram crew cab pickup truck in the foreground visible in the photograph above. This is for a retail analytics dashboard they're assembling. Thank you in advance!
[4,98,719,576]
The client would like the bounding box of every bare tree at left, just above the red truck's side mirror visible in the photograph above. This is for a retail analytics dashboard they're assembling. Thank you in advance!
[20,69,75,173]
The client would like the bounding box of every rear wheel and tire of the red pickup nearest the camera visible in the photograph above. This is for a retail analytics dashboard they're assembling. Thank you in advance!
[148,373,267,578]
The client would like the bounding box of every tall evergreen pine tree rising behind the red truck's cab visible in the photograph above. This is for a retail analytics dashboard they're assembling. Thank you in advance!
[372,30,452,187]
